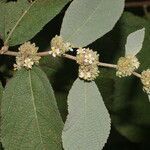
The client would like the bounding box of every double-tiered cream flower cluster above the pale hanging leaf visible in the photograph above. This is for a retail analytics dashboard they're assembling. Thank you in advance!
[76,48,99,81]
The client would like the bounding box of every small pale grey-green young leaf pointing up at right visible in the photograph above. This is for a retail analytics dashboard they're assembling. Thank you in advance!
[125,28,145,56]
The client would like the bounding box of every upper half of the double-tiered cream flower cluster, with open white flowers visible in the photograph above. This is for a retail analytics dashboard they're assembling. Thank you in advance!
[76,48,99,66]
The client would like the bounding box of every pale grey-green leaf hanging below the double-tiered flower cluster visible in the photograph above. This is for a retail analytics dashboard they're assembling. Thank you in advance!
[62,79,110,150]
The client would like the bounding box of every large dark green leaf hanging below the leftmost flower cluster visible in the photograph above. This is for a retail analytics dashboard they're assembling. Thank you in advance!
[2,67,63,150]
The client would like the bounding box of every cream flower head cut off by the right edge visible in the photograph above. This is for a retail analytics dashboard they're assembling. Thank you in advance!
[141,69,150,94]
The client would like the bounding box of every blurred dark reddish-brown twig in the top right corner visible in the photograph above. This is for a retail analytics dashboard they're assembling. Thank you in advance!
[125,1,150,7]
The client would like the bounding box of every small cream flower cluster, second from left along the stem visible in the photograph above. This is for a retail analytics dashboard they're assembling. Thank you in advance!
[49,35,72,57]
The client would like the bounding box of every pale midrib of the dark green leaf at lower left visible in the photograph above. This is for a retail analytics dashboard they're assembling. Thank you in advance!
[29,71,46,150]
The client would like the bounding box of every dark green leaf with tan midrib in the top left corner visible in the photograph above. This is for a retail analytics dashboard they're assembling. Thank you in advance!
[0,0,70,46]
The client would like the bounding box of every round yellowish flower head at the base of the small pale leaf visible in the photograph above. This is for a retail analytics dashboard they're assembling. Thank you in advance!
[116,55,140,77]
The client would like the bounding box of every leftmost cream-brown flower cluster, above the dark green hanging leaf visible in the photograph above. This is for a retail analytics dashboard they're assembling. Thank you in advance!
[14,42,41,70]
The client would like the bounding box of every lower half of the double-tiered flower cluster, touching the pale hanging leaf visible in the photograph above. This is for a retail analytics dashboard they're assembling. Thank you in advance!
[79,65,99,81]
